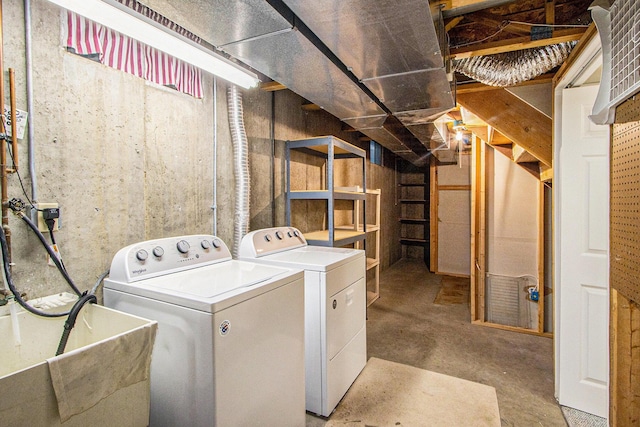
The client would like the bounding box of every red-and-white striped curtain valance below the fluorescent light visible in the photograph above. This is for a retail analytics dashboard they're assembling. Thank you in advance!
[66,10,203,98]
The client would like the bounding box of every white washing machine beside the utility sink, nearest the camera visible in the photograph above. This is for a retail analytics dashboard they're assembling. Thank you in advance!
[104,235,305,427]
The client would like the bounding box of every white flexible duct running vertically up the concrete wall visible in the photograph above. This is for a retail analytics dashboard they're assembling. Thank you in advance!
[227,85,249,258]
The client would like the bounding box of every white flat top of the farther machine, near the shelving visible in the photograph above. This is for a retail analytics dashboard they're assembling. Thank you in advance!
[256,246,364,271]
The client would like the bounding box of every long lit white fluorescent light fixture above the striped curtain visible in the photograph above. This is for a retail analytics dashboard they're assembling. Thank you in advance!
[49,0,259,89]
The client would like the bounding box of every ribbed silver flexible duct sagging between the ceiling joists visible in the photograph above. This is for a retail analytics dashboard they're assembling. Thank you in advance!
[454,42,576,87]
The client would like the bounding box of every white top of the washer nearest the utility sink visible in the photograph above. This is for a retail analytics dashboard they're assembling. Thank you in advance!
[105,260,303,313]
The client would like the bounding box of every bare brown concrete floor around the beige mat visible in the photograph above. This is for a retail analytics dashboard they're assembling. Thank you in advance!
[307,259,567,427]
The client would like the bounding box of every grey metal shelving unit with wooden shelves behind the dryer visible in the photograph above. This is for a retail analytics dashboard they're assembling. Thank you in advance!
[285,136,368,246]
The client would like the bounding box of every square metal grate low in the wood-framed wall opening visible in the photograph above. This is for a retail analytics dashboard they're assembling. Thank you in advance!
[486,274,537,329]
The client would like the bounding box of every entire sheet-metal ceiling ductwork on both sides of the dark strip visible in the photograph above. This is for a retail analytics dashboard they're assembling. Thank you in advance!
[160,0,455,163]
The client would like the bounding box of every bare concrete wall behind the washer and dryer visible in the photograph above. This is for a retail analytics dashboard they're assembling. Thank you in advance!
[3,0,401,298]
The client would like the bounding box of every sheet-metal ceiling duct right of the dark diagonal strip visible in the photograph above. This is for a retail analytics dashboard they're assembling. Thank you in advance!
[283,0,455,164]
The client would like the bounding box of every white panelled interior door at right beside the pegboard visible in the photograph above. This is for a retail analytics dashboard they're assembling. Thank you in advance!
[554,85,609,418]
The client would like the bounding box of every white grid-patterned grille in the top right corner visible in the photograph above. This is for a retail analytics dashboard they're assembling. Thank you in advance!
[609,0,640,103]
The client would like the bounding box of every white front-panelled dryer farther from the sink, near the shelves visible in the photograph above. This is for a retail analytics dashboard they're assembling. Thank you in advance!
[239,227,367,417]
